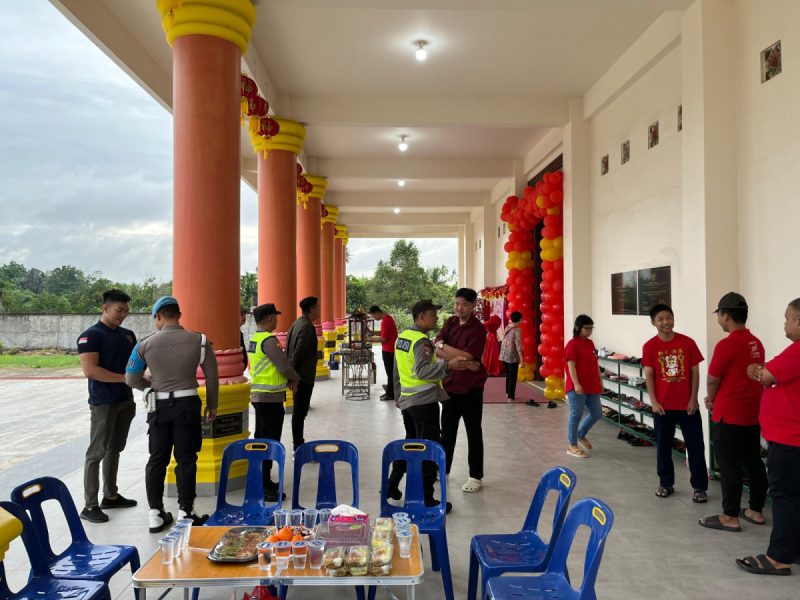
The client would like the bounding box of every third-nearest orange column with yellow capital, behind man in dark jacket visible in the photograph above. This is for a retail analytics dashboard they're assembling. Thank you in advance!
[296,174,330,379]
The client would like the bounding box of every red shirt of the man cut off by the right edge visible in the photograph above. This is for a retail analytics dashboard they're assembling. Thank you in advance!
[759,342,800,446]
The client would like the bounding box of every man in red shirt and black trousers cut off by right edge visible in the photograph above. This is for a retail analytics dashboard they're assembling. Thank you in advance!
[736,298,800,575]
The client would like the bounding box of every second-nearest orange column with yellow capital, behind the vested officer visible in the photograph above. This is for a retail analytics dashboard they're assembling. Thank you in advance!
[253,117,305,332]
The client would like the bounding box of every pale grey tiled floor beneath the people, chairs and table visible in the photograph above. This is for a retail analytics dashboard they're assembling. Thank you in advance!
[0,372,800,600]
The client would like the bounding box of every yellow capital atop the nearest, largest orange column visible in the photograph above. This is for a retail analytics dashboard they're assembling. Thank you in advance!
[156,0,256,55]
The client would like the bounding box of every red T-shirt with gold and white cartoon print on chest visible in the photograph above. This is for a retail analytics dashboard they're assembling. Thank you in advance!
[642,333,703,410]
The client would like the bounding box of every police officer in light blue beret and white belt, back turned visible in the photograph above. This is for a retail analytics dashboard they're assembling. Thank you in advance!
[125,296,219,533]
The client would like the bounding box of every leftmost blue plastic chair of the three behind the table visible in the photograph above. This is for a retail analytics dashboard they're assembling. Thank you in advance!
[206,439,286,526]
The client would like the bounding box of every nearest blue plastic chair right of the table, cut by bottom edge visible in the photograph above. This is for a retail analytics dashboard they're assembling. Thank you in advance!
[485,498,614,600]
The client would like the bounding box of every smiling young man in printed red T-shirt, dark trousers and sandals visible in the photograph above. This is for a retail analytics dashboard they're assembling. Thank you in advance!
[642,304,708,503]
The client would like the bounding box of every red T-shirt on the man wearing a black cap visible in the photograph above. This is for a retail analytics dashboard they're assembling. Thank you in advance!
[708,329,764,425]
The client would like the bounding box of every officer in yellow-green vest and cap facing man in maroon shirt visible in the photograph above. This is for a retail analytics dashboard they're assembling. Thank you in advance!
[388,300,474,513]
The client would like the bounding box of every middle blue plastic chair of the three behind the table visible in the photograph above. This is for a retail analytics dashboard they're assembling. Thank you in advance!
[292,440,358,509]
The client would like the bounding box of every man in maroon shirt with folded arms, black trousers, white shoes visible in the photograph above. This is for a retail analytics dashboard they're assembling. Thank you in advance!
[434,288,486,492]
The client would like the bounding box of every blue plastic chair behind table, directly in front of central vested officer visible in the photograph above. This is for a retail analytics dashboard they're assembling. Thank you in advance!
[369,439,453,600]
